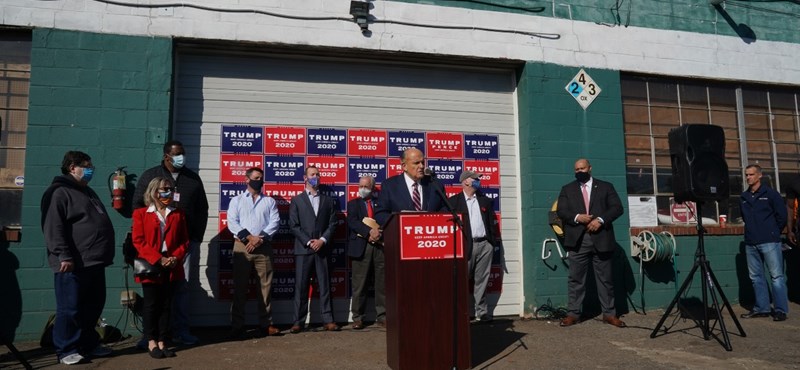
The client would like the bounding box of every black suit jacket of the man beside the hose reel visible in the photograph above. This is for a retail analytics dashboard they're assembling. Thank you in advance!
[557,178,623,252]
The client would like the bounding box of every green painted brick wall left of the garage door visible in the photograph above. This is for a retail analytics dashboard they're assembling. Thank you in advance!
[10,29,173,339]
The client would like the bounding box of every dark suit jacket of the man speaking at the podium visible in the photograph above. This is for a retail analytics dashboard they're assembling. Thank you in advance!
[375,173,446,225]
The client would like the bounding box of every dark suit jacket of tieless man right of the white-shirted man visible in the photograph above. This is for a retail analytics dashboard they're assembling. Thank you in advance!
[289,190,336,255]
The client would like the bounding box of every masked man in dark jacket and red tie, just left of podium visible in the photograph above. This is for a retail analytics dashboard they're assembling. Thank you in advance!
[347,176,386,330]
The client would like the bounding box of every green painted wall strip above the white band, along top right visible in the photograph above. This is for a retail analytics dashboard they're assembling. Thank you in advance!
[393,0,800,43]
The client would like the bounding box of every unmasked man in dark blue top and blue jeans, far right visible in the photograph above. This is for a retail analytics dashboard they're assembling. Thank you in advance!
[741,165,789,321]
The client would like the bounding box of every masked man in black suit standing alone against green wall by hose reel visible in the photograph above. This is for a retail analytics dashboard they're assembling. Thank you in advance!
[558,159,625,328]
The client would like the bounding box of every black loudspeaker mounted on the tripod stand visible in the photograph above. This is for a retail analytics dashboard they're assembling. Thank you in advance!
[669,124,730,203]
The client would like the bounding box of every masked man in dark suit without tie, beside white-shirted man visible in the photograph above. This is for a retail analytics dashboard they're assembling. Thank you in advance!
[289,166,339,334]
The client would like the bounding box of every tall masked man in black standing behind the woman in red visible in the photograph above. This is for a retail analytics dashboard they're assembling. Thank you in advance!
[132,140,208,345]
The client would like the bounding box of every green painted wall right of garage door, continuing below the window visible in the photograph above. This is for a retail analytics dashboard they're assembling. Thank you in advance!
[518,62,749,313]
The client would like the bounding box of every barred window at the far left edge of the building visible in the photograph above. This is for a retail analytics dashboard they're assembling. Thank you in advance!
[0,30,31,228]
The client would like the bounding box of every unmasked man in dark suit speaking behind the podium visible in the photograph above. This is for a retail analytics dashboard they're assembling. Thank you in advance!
[375,148,444,225]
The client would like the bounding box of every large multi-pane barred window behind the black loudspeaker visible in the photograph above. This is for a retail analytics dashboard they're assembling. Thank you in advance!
[621,74,800,225]
